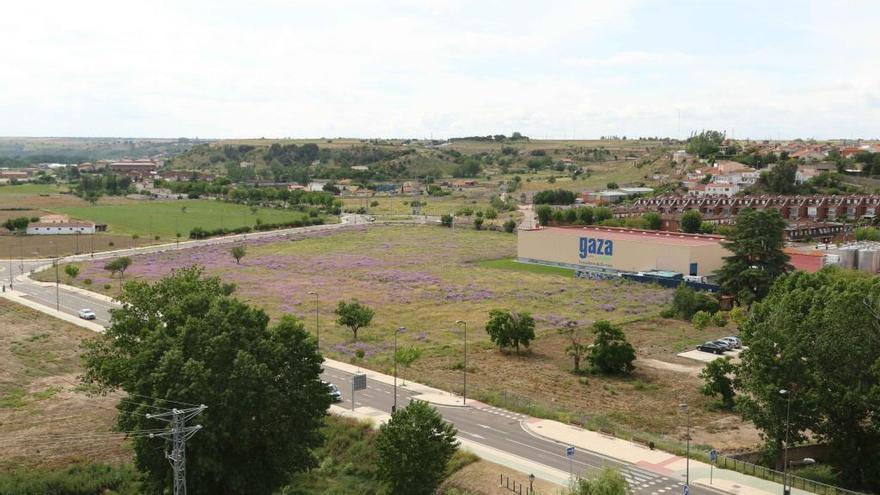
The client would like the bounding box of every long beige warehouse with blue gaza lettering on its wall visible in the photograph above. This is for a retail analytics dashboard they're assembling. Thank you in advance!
[517,227,730,276]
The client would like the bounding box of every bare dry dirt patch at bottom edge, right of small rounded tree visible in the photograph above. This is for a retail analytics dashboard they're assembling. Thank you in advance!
[441,461,561,495]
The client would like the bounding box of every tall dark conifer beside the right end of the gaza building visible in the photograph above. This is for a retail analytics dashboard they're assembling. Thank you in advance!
[718,208,792,305]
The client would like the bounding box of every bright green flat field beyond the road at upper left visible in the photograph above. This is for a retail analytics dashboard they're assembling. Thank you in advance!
[54,199,326,238]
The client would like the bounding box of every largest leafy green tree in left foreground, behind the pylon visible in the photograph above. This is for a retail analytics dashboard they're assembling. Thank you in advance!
[83,267,331,495]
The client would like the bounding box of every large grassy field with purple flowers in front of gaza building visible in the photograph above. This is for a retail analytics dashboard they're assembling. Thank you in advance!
[55,226,757,448]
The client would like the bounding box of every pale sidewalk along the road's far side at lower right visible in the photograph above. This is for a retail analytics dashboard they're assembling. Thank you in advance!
[523,418,810,495]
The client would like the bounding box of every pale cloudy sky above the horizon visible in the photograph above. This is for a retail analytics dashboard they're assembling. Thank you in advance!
[0,0,880,139]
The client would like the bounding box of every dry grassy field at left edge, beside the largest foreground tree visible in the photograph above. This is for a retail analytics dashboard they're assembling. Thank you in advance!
[0,299,131,471]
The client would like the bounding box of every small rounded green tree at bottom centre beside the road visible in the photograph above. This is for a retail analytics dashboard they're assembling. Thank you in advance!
[376,400,458,495]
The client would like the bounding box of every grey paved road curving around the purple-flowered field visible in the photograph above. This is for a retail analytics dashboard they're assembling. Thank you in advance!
[0,224,717,495]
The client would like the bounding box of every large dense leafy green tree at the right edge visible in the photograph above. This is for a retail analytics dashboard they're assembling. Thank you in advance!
[736,268,880,491]
